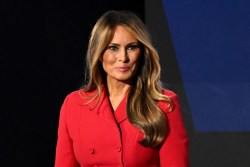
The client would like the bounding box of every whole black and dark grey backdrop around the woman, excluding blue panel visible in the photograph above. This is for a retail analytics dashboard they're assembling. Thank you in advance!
[0,0,250,167]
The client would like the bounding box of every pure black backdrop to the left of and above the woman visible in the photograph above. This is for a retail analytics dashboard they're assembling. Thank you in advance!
[0,0,144,167]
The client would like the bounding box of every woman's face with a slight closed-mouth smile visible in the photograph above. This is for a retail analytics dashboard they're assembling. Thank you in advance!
[102,25,141,82]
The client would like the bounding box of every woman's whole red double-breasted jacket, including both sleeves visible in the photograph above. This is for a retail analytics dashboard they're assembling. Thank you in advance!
[55,87,189,167]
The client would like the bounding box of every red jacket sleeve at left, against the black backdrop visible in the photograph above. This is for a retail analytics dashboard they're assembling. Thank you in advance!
[55,97,79,167]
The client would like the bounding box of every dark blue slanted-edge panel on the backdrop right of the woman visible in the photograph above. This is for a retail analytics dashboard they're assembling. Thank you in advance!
[163,0,250,132]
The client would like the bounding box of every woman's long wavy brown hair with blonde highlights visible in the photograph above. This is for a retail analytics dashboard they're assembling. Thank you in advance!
[82,10,172,146]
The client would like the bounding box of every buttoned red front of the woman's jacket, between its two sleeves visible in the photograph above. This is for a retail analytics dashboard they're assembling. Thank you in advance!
[68,99,159,166]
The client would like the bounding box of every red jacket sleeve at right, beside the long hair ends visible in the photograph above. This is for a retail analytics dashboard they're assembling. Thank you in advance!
[160,93,189,167]
